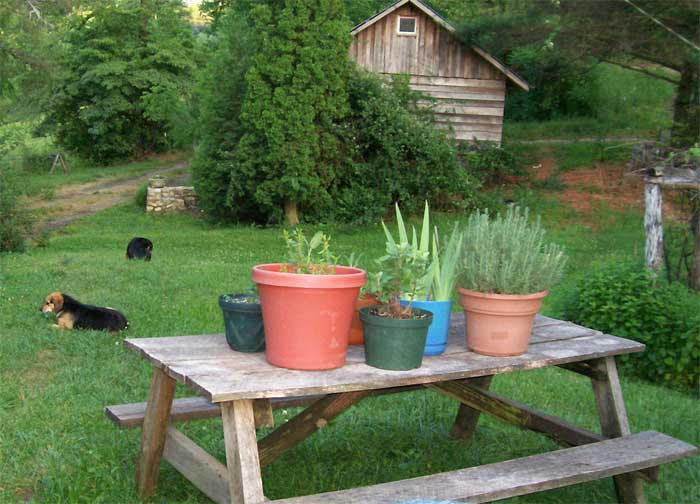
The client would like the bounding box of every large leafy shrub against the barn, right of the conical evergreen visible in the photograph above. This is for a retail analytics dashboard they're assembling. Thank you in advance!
[333,70,478,222]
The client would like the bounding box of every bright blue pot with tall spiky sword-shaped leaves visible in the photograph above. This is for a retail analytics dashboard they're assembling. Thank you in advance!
[396,201,462,355]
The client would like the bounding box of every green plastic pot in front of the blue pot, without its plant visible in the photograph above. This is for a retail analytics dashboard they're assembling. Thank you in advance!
[360,306,433,371]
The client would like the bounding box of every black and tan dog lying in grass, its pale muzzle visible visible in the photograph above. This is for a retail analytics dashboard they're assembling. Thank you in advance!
[39,292,129,331]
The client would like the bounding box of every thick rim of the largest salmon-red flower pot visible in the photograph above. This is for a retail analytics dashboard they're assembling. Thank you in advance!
[252,263,366,289]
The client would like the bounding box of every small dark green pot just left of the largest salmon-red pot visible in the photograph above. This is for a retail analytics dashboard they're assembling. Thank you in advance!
[219,294,265,352]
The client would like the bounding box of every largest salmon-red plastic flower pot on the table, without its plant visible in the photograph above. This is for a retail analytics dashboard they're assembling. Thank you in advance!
[253,263,365,370]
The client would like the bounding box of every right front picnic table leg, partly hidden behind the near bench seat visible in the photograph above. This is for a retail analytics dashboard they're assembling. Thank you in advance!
[591,357,646,504]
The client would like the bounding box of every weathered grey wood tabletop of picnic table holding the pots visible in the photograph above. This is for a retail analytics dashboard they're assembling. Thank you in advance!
[124,313,644,403]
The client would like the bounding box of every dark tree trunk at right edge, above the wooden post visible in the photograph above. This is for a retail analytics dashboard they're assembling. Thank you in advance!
[671,55,700,147]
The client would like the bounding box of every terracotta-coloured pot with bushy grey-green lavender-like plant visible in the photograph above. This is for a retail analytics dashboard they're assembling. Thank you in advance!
[457,207,566,356]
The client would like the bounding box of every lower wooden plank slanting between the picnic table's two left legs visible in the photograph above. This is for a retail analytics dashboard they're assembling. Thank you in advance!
[163,427,230,503]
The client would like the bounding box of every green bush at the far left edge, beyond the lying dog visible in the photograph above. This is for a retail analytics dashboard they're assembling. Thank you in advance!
[0,160,31,252]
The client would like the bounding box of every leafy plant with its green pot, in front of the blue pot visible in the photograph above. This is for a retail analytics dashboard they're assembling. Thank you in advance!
[360,205,433,370]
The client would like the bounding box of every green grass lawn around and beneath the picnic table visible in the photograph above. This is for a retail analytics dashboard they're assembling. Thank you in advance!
[0,200,700,503]
